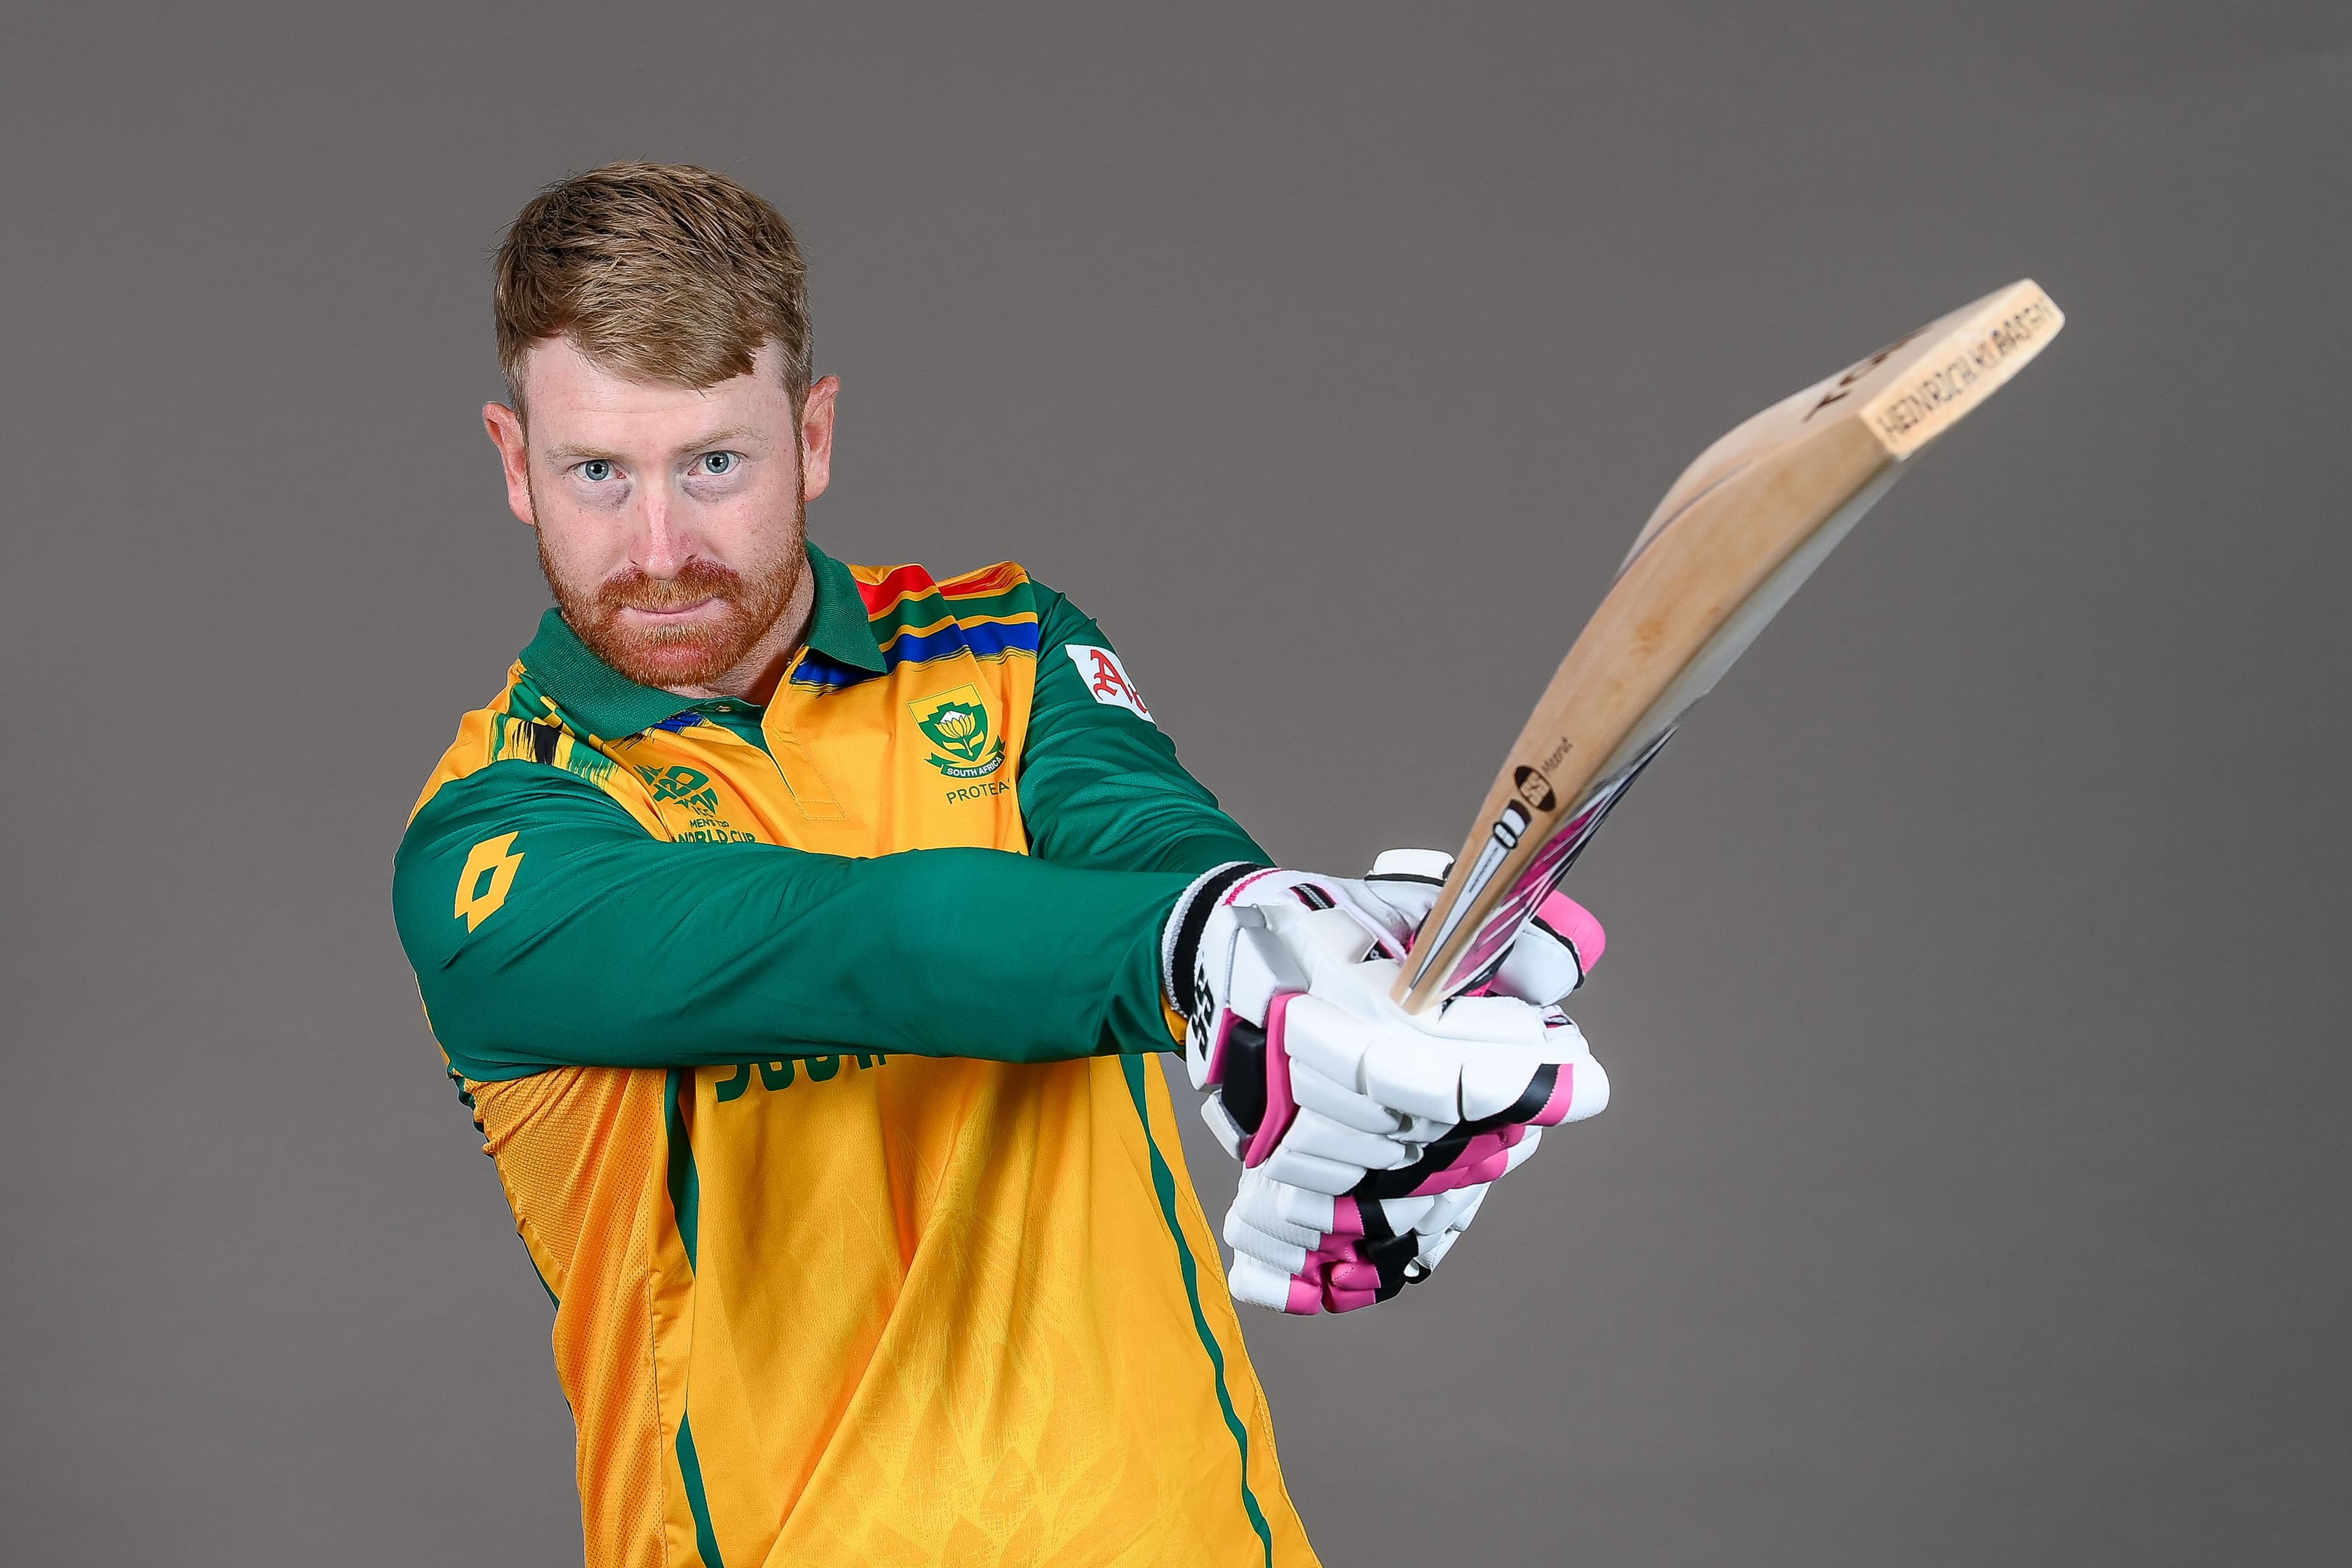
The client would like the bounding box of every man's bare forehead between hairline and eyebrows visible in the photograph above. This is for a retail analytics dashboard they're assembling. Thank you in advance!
[518,339,797,447]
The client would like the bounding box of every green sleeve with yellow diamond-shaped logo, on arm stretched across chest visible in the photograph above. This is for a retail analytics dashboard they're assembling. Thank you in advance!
[393,760,1190,1079]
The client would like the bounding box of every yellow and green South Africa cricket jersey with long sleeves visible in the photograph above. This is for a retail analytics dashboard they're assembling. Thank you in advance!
[393,545,1315,1568]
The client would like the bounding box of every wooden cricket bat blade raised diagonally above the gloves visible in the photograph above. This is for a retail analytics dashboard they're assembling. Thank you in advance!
[1395,280,2065,1013]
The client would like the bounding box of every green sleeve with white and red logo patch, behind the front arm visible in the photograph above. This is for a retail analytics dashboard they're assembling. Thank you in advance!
[1021,581,1272,875]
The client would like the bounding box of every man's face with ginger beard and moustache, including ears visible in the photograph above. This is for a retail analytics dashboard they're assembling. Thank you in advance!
[482,339,840,693]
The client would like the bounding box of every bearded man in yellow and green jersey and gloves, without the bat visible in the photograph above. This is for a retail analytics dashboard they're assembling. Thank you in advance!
[393,165,1607,1568]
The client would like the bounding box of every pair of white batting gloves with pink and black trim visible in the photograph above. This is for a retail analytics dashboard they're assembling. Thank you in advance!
[1167,851,1609,1312]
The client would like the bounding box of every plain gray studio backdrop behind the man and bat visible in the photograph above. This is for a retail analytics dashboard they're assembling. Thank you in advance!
[0,0,2352,1566]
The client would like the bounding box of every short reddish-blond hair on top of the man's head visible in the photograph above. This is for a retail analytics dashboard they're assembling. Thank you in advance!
[494,162,809,409]
